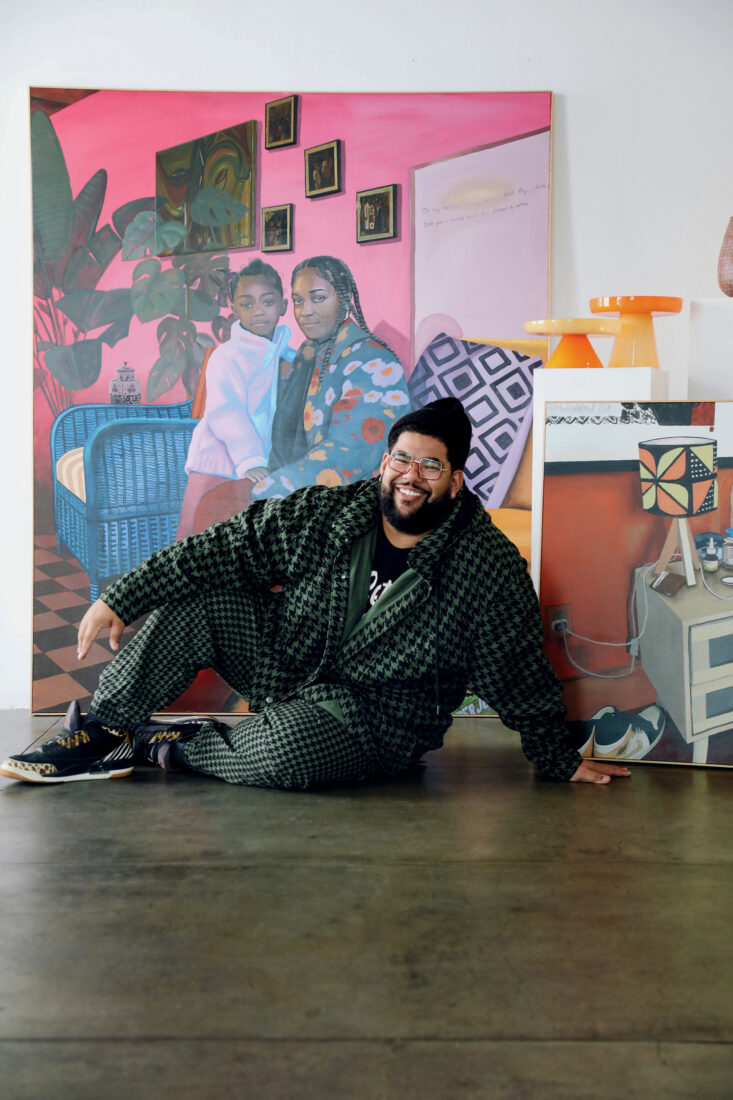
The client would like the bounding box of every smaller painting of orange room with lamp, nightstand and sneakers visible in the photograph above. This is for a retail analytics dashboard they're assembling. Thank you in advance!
[535,402,733,767]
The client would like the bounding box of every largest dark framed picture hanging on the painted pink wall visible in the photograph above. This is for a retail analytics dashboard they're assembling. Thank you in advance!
[155,122,258,256]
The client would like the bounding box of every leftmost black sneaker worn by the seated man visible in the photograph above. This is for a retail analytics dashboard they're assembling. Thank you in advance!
[0,712,133,783]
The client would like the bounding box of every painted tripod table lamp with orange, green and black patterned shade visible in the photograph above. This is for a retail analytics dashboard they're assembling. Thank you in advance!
[638,436,718,585]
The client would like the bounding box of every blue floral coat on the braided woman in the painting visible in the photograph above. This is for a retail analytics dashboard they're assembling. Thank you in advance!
[252,321,409,501]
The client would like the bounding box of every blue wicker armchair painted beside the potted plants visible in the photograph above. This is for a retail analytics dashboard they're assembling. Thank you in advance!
[51,402,197,601]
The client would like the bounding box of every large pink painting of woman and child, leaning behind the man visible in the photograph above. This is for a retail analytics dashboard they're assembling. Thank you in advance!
[31,89,551,714]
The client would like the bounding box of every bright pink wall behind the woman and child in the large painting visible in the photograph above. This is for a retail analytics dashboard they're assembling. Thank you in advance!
[35,91,550,517]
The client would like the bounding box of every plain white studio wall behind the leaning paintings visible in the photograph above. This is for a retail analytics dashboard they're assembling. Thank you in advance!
[0,0,733,707]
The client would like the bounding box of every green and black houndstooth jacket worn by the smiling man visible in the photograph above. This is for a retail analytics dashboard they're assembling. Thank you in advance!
[102,480,581,779]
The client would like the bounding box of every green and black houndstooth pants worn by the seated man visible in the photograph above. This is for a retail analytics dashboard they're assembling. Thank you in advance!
[90,593,375,790]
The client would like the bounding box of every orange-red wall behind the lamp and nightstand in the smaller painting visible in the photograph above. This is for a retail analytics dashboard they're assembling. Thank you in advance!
[539,469,733,717]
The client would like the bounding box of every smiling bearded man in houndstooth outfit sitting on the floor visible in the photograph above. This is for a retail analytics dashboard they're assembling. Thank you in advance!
[0,398,628,790]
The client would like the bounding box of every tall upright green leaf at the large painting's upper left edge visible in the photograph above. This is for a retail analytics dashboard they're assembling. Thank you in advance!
[31,111,74,263]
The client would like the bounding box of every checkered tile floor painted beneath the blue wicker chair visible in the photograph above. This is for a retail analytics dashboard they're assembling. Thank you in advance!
[32,535,121,714]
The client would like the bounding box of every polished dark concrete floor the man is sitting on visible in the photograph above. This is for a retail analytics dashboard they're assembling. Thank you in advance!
[0,711,733,1100]
